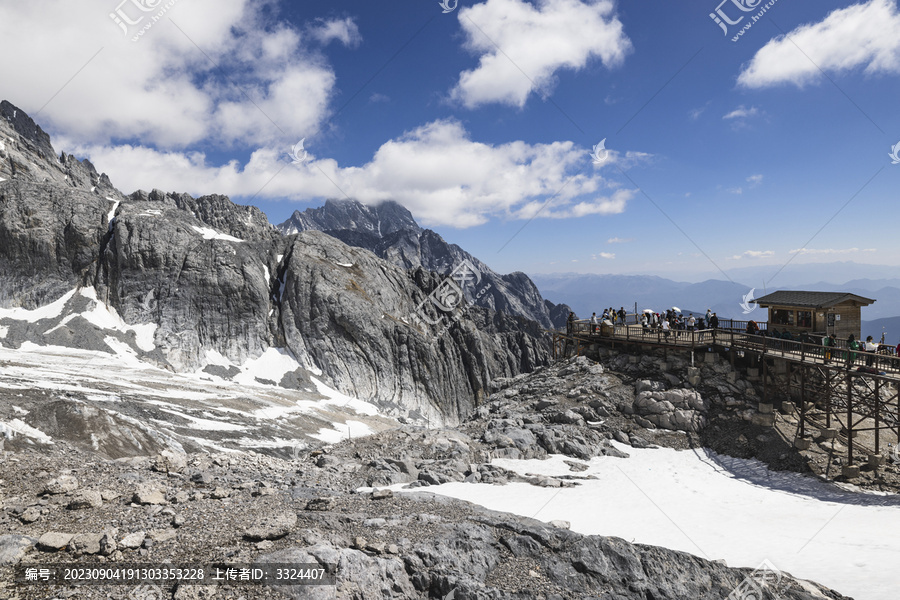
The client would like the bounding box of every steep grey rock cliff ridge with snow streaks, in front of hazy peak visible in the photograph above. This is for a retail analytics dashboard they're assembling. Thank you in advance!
[0,103,549,423]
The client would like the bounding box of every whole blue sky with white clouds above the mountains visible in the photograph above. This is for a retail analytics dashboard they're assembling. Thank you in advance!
[0,0,900,279]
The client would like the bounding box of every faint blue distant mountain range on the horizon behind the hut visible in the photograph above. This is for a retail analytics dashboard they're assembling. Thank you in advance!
[532,272,900,343]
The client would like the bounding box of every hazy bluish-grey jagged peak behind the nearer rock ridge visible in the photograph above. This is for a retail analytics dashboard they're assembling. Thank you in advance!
[278,200,569,329]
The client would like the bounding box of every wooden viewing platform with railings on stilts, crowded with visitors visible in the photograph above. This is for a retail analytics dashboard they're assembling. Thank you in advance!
[553,315,900,477]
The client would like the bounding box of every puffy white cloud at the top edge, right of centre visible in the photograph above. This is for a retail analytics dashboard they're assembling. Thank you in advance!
[451,0,632,108]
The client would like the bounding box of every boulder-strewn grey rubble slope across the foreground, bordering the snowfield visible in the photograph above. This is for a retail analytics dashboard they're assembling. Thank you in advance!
[0,355,856,600]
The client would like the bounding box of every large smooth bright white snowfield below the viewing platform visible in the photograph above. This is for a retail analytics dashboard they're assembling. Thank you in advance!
[402,442,900,600]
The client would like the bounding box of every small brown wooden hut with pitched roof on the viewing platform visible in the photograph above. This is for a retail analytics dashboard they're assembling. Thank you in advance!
[755,290,875,340]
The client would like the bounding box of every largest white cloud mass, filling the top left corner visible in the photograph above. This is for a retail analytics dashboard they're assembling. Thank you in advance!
[0,0,335,149]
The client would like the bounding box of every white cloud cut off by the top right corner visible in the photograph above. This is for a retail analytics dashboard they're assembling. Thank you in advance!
[738,0,900,88]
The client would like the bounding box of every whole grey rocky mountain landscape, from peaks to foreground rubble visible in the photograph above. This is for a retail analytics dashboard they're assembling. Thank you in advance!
[0,103,880,600]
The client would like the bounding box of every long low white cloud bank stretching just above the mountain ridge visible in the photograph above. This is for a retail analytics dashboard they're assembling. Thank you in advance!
[68,121,635,227]
